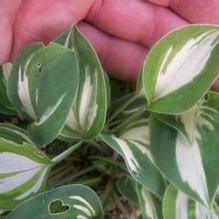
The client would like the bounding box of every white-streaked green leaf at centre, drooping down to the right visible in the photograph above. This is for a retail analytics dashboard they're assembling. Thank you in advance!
[101,121,165,197]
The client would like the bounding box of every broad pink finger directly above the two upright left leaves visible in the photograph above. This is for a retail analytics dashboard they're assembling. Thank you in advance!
[12,0,94,60]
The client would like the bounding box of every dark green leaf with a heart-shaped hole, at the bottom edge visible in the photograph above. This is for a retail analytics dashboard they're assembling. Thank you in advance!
[6,185,103,219]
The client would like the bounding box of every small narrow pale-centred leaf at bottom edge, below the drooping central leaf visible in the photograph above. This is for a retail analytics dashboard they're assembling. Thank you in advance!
[136,185,162,219]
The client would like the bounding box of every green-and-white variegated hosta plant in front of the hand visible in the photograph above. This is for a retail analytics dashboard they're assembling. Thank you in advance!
[0,25,219,219]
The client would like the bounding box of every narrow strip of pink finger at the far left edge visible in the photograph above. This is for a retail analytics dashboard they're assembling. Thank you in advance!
[0,0,21,64]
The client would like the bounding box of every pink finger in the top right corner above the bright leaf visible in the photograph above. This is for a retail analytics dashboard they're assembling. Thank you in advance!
[152,0,219,24]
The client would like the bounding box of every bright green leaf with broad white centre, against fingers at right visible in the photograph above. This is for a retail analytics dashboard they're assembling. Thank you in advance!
[143,25,219,114]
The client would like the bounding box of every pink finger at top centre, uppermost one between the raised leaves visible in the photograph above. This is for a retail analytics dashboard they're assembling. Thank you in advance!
[87,0,187,46]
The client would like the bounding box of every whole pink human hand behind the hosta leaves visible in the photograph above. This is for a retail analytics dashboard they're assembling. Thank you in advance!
[0,0,219,90]
